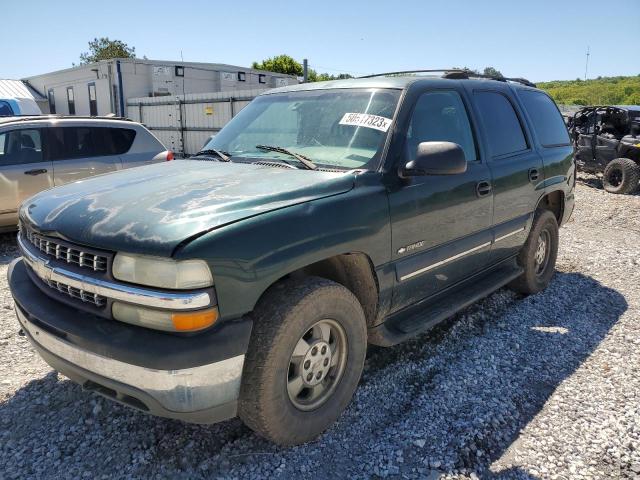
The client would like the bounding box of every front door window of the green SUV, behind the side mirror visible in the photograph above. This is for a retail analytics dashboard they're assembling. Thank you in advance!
[407,91,477,162]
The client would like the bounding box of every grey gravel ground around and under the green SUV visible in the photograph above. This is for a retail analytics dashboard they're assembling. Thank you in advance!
[0,177,640,479]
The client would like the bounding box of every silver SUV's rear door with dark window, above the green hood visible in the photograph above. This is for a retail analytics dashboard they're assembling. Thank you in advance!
[47,126,122,186]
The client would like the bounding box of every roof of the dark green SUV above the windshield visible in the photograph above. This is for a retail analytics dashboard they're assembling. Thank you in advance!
[261,75,531,95]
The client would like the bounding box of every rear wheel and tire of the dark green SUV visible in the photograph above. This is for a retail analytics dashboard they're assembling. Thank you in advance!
[509,210,559,295]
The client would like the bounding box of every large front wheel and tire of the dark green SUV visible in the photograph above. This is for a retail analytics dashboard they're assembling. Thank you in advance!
[238,277,367,445]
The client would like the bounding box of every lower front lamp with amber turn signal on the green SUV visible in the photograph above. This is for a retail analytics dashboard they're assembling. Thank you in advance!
[111,302,218,332]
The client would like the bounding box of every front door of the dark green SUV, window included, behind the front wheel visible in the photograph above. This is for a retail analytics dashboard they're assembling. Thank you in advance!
[389,90,493,311]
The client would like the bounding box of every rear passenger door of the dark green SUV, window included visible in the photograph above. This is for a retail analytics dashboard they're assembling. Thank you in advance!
[472,85,544,262]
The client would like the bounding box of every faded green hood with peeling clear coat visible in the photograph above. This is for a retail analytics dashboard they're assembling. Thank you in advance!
[21,160,354,256]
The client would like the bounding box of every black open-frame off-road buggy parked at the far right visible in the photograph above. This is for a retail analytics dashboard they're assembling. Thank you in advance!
[569,105,640,193]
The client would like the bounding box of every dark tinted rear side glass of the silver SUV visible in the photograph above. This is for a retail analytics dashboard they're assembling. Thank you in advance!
[49,127,136,160]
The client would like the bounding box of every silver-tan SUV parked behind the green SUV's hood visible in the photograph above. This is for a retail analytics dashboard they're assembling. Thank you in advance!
[0,116,173,231]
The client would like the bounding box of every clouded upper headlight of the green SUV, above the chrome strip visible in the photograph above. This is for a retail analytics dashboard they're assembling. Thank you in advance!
[113,253,213,290]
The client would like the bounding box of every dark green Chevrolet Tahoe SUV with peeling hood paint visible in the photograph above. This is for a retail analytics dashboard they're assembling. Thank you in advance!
[9,72,575,444]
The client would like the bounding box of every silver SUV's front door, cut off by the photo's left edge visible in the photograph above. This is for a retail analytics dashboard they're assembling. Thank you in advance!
[0,128,53,227]
